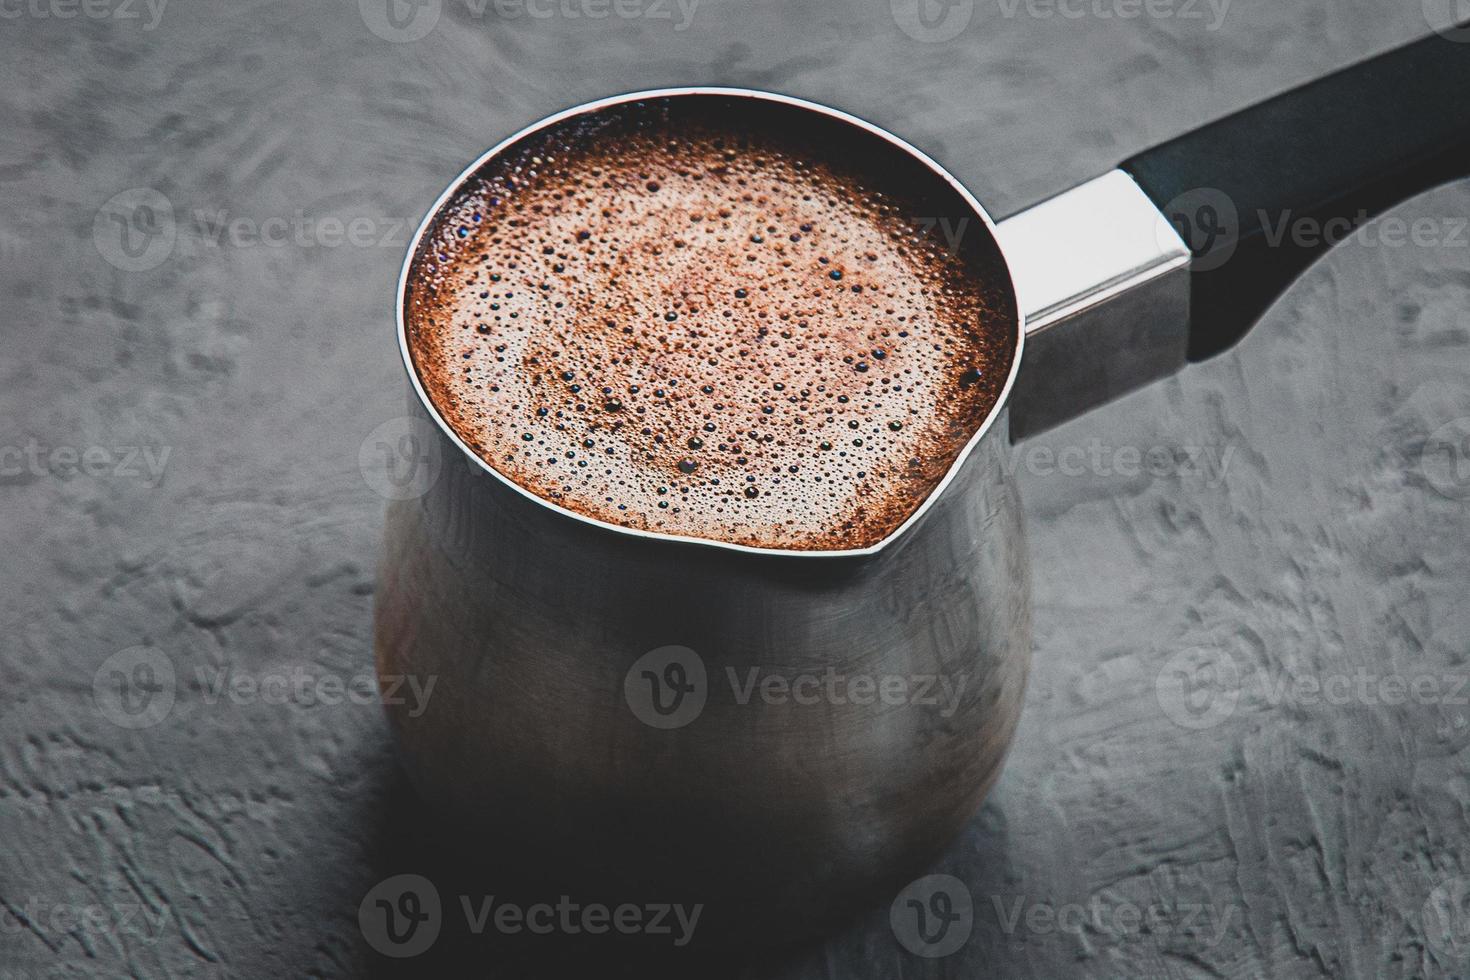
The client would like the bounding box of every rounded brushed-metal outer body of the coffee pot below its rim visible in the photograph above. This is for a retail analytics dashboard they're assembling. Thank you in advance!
[376,398,1030,936]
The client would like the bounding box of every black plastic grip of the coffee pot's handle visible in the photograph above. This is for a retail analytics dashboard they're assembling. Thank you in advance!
[1122,28,1470,360]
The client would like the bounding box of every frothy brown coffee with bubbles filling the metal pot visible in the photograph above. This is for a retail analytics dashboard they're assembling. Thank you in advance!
[406,103,1014,551]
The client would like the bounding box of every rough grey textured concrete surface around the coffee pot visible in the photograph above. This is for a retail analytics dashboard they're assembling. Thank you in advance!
[0,0,1470,979]
